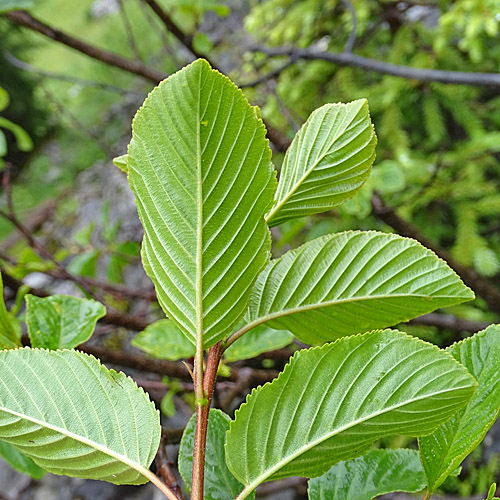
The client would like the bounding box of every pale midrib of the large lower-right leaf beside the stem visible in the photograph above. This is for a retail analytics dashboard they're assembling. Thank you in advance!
[238,385,472,499]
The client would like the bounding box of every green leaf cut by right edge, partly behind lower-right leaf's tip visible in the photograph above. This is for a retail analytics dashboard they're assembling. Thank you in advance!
[419,325,500,493]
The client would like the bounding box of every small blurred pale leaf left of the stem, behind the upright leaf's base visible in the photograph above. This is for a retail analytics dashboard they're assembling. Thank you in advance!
[132,319,195,361]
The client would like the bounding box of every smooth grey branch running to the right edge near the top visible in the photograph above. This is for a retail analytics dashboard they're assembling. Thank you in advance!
[253,46,500,87]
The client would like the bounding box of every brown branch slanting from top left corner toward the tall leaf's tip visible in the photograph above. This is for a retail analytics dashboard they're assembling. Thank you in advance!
[4,10,167,83]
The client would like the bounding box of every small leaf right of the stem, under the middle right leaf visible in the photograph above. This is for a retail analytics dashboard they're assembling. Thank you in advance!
[224,325,293,362]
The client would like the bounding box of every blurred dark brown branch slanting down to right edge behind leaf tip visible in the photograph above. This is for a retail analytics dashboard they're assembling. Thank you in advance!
[371,195,500,313]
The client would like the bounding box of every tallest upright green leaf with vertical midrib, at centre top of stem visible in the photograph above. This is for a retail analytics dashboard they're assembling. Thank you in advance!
[127,60,276,347]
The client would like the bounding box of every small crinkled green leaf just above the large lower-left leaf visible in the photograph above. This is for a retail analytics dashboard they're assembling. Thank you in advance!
[26,295,106,349]
